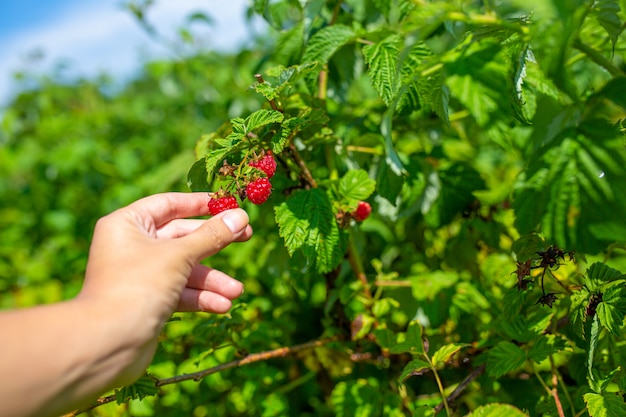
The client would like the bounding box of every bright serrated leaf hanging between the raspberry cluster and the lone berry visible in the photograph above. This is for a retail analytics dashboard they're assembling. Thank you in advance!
[275,188,346,273]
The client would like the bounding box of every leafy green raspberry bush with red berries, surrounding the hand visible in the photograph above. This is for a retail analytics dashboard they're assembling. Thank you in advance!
[0,0,626,417]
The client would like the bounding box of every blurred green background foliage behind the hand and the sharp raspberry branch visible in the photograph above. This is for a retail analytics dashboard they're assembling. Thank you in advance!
[0,0,626,417]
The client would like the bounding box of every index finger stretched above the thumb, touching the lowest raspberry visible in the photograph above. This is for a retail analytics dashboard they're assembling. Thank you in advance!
[127,192,209,228]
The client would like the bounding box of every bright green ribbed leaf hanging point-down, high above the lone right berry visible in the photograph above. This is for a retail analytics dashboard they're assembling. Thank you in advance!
[363,34,402,106]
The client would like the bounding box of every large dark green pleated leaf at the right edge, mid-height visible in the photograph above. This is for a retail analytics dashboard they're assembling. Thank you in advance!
[513,131,626,253]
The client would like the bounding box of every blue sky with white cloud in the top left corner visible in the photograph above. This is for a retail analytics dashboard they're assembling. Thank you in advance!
[0,0,263,108]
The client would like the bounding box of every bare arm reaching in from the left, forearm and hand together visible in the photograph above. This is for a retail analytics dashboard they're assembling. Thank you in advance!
[0,193,252,417]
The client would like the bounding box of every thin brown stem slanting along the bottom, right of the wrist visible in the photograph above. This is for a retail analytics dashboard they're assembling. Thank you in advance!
[63,336,339,417]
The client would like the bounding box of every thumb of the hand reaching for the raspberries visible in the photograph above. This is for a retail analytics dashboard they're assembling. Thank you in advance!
[180,209,251,261]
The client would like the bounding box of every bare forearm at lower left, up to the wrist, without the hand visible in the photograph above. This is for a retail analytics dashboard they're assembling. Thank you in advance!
[0,299,152,417]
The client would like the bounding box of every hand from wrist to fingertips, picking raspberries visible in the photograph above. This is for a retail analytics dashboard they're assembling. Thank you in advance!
[78,193,252,380]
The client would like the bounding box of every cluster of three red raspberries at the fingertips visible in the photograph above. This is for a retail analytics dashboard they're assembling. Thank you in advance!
[208,151,276,216]
